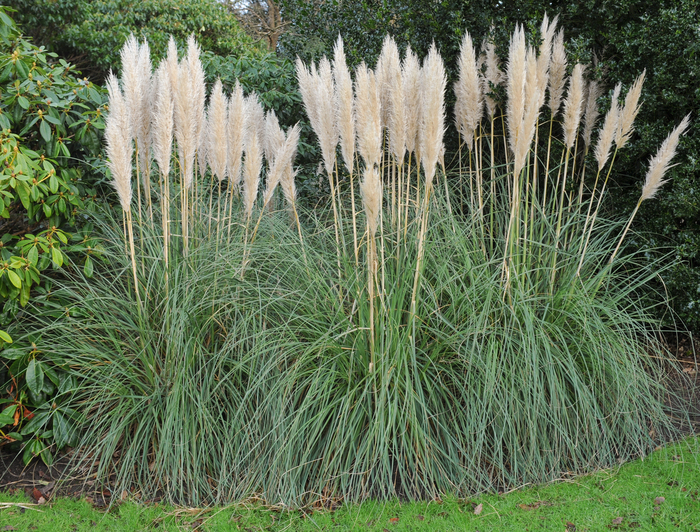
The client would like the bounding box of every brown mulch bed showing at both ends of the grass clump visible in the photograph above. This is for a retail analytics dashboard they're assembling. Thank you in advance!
[0,333,700,508]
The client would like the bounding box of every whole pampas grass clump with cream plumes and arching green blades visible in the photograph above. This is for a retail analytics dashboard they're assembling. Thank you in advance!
[13,20,688,506]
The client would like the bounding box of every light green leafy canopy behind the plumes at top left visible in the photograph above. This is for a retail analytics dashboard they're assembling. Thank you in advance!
[7,0,263,79]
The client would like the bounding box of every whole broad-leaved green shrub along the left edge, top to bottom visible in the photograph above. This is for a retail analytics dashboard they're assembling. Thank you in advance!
[0,8,106,463]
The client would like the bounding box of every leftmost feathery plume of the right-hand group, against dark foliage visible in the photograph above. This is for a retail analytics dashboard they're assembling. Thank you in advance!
[454,32,484,150]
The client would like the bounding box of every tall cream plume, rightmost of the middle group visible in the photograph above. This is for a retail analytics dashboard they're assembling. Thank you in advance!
[420,43,447,189]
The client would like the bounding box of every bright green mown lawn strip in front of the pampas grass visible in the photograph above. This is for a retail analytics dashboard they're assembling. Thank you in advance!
[0,438,700,532]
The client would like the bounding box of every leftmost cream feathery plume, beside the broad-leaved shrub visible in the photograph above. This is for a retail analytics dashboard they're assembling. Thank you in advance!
[105,72,133,212]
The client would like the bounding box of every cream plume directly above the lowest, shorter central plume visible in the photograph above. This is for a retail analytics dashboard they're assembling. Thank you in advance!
[355,63,382,167]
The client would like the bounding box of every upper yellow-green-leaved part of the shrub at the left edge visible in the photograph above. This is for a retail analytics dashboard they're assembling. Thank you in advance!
[0,6,106,314]
